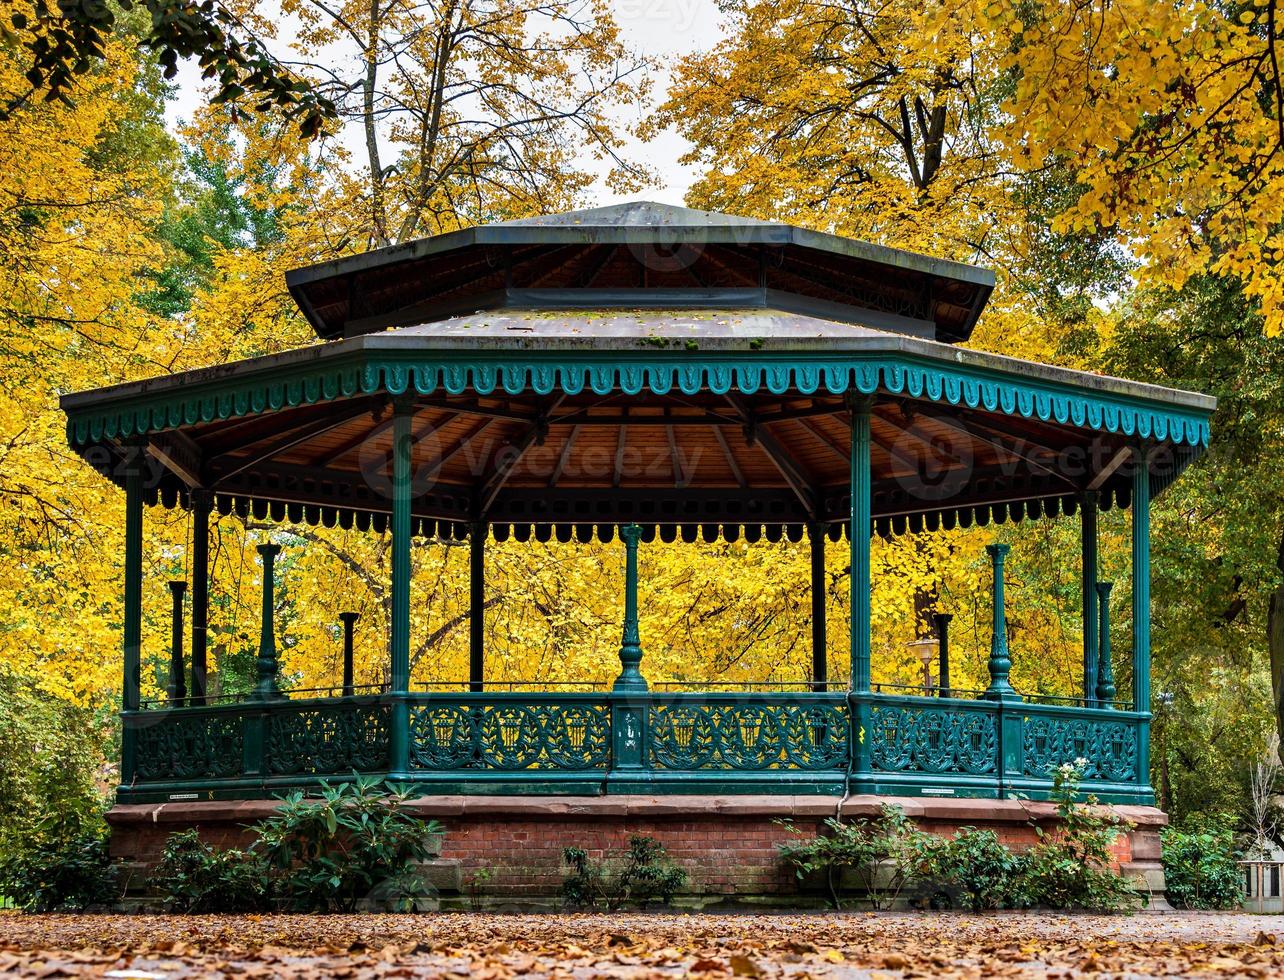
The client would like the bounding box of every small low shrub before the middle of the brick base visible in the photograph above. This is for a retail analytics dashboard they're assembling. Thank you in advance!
[562,835,687,911]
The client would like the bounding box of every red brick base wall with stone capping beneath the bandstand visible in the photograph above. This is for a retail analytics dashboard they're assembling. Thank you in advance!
[108,796,1167,900]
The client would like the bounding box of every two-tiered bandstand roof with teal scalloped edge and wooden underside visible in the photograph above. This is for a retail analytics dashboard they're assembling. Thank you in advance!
[63,204,1215,539]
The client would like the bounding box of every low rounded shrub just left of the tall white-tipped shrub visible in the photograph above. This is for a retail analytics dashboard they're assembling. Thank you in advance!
[918,827,1030,912]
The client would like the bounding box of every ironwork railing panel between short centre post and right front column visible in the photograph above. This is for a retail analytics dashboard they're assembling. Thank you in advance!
[650,700,849,771]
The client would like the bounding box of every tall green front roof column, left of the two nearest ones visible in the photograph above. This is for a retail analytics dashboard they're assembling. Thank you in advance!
[388,403,413,776]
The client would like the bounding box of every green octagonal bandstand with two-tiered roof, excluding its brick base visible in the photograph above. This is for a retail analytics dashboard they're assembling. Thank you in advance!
[62,203,1213,893]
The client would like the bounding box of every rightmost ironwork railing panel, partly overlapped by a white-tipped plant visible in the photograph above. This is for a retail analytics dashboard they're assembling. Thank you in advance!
[1025,715,1138,782]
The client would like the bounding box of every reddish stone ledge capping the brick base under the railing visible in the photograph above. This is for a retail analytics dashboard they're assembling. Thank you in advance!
[107,794,1168,828]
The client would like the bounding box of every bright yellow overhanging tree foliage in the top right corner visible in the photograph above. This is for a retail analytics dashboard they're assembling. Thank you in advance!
[981,0,1284,335]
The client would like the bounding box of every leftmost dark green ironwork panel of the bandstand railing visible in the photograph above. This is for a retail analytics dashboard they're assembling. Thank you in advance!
[130,709,244,782]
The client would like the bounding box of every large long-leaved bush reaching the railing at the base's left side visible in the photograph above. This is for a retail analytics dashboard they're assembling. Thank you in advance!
[253,776,442,912]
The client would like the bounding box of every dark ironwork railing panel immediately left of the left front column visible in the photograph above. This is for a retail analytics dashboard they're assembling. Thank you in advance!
[265,704,388,776]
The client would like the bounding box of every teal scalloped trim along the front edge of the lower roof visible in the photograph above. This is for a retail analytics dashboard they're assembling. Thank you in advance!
[67,353,1208,446]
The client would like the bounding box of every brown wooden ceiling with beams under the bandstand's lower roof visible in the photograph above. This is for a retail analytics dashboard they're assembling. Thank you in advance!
[140,392,1129,536]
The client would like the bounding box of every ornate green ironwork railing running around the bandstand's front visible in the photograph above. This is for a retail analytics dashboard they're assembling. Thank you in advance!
[121,691,1153,803]
